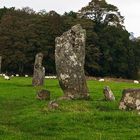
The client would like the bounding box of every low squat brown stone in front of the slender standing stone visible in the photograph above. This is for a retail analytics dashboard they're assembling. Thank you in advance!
[37,89,50,100]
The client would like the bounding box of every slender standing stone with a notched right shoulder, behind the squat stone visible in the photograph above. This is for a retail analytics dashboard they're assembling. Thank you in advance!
[32,53,45,86]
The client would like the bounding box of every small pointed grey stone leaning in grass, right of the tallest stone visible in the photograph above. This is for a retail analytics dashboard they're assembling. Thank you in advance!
[103,86,115,101]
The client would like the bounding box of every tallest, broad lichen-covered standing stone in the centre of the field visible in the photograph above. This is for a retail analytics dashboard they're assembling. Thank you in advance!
[55,25,89,99]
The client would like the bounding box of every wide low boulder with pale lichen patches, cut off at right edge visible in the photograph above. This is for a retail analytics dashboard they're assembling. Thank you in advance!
[119,89,140,110]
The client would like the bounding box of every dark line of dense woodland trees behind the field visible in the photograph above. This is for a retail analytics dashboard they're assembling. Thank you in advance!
[0,0,140,79]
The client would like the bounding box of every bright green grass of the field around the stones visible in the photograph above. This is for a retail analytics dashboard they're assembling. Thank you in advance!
[0,77,140,140]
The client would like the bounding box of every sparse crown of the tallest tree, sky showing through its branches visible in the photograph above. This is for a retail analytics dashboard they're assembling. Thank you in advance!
[78,0,124,26]
